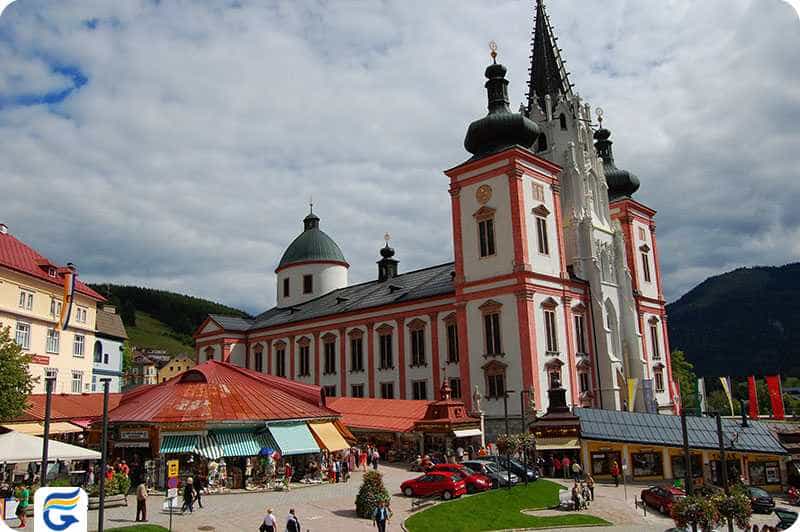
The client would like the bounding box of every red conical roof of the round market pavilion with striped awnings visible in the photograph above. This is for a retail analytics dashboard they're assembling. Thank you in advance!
[109,360,338,423]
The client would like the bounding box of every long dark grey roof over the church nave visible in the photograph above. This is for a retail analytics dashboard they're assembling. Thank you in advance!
[211,262,455,331]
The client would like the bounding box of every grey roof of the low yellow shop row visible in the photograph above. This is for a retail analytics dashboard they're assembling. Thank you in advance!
[575,408,787,454]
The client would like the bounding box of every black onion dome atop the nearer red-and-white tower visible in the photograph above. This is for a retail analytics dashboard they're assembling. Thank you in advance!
[464,48,541,159]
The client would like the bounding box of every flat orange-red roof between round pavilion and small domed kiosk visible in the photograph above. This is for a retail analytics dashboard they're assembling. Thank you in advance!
[326,397,430,432]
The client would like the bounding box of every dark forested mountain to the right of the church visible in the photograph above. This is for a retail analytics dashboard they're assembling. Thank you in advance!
[667,263,800,376]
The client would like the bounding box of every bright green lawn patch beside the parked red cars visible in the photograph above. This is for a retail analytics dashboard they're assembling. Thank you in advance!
[406,480,610,532]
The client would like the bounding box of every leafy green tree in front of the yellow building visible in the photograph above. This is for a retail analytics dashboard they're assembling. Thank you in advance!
[0,327,34,421]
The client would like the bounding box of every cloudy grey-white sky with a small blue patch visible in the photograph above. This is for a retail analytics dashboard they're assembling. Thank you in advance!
[0,0,800,313]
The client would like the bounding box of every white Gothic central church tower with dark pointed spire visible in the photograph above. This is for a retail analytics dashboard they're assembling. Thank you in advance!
[525,0,648,410]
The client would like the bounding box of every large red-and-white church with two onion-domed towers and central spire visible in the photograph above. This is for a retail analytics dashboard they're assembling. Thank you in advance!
[195,1,678,436]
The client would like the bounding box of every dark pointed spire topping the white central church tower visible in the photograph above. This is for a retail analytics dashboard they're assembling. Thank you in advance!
[527,0,572,115]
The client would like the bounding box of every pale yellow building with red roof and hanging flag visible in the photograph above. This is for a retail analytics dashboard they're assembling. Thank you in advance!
[0,224,105,393]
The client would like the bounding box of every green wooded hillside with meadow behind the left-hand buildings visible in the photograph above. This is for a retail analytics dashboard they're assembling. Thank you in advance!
[91,284,248,355]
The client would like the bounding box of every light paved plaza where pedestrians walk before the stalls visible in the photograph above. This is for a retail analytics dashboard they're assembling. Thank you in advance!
[90,466,785,532]
